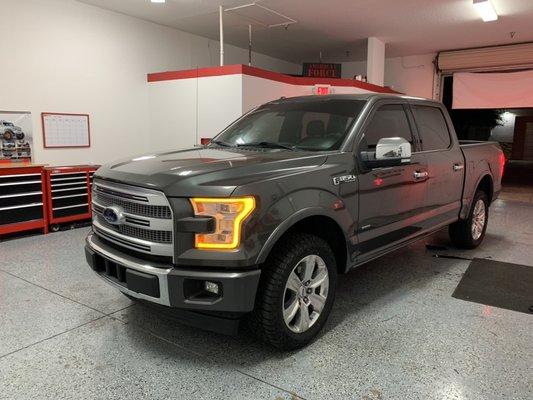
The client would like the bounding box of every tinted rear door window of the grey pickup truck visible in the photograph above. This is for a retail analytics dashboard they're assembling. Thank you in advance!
[413,106,451,150]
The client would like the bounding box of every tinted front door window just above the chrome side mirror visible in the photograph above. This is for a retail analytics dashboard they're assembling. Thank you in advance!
[365,104,414,151]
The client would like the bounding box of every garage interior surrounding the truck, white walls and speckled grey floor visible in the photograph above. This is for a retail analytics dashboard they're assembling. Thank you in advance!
[0,0,533,400]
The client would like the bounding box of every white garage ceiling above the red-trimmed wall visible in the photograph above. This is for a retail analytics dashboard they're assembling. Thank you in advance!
[79,0,533,63]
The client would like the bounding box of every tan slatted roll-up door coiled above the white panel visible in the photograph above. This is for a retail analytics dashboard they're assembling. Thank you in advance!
[437,43,533,73]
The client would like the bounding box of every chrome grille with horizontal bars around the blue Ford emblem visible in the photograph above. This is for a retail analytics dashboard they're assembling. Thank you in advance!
[92,178,174,257]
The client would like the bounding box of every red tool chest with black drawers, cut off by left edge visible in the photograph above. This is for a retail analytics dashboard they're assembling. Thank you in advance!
[0,163,48,236]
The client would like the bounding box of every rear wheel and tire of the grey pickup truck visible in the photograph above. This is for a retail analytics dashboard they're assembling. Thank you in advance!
[448,190,489,249]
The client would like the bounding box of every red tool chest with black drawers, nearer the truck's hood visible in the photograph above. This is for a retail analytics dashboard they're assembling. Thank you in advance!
[45,165,98,230]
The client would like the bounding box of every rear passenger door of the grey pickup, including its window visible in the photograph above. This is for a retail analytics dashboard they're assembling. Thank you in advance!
[411,103,465,228]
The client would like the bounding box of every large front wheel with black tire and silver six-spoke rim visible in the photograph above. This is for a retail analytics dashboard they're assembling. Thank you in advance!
[250,233,337,350]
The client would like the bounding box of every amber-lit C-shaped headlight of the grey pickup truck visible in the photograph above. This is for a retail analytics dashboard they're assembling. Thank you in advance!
[191,197,255,249]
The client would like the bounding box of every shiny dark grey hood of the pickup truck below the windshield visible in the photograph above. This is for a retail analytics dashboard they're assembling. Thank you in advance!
[95,147,327,197]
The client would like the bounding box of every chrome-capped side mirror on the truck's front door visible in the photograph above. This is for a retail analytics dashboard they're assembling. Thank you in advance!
[361,137,411,168]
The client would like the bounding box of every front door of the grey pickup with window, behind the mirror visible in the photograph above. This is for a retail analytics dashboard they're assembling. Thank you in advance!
[356,101,427,261]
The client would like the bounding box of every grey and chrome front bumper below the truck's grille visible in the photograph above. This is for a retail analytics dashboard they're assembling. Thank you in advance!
[85,233,261,313]
